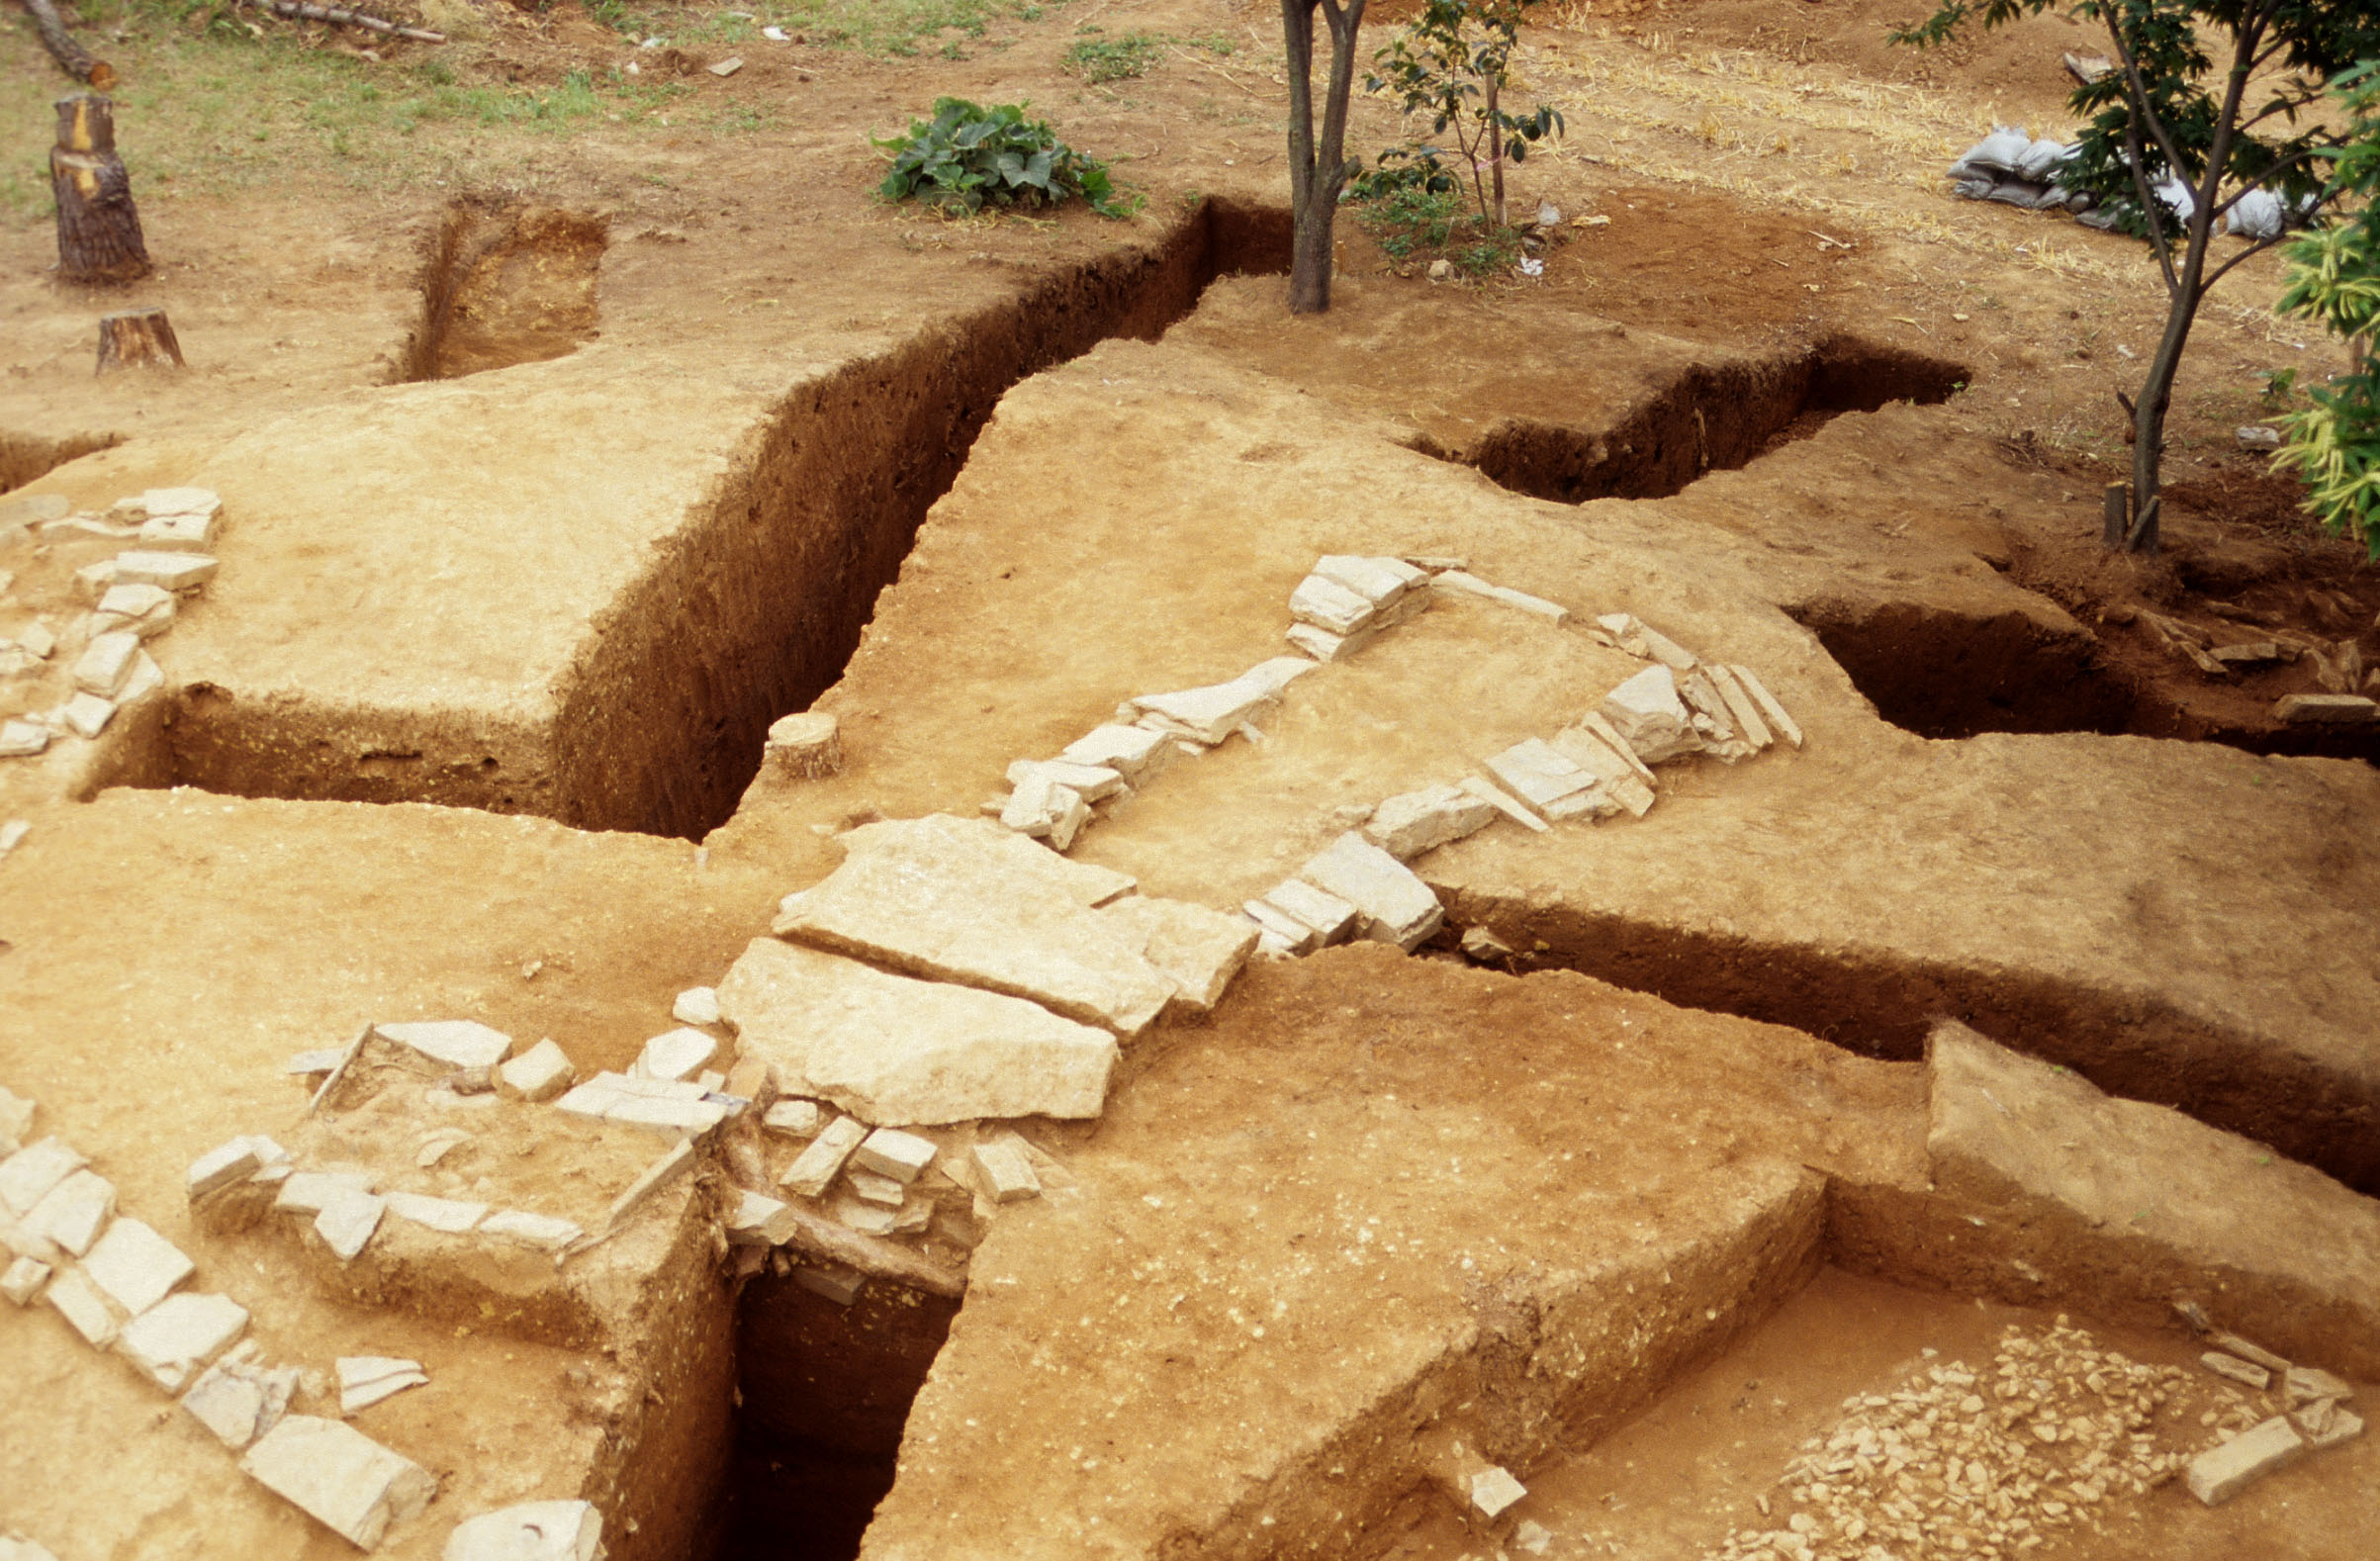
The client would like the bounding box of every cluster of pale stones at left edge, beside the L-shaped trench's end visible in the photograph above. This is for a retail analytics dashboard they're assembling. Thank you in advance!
[0,488,224,759]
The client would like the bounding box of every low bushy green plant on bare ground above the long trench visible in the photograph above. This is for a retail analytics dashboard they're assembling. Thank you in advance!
[875,98,1140,217]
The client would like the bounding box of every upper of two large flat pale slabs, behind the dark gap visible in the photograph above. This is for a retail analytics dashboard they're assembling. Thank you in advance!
[774,814,1176,1035]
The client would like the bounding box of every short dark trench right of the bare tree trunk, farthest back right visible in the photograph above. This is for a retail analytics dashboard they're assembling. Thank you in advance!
[1414,335,1968,505]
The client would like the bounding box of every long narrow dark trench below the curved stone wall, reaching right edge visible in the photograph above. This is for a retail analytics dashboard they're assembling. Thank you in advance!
[1442,887,2380,1195]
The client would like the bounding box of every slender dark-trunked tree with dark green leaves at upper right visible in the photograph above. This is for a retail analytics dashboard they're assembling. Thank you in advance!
[1892,0,2380,552]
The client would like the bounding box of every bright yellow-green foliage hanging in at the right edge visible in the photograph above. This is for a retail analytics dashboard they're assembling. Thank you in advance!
[2273,59,2380,559]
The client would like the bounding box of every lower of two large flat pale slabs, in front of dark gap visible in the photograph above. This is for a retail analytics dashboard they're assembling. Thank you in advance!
[719,938,1116,1126]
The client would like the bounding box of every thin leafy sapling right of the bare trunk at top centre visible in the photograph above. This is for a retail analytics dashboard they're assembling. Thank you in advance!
[1364,0,1564,229]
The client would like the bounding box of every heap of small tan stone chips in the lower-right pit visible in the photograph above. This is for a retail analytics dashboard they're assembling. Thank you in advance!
[1711,1316,2361,1561]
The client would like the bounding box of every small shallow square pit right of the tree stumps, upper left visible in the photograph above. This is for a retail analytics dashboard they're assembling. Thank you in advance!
[398,198,607,381]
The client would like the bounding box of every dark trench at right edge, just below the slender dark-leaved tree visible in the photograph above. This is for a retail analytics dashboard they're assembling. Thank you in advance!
[1789,599,2380,764]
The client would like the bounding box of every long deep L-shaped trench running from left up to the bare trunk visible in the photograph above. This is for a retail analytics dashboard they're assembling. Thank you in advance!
[153,200,1290,838]
